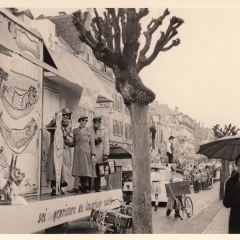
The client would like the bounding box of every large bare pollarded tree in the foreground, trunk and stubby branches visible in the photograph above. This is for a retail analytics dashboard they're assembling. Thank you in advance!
[73,8,183,233]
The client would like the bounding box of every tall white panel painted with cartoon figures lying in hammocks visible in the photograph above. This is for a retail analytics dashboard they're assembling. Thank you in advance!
[0,53,43,197]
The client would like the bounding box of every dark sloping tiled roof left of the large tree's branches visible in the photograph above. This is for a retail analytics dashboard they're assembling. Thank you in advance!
[47,14,83,54]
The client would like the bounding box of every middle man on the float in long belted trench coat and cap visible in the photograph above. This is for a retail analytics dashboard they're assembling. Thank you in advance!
[69,115,95,193]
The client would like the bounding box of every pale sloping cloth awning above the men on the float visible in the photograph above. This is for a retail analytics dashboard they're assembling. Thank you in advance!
[48,44,113,102]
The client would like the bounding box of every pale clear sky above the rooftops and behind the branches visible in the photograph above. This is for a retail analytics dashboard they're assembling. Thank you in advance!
[3,0,240,128]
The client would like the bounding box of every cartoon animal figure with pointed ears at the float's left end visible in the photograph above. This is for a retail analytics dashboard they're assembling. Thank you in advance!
[0,155,25,202]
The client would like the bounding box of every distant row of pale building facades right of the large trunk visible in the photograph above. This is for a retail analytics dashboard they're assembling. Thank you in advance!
[150,101,214,163]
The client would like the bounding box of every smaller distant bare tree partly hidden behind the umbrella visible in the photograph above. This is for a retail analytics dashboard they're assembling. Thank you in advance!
[212,124,240,200]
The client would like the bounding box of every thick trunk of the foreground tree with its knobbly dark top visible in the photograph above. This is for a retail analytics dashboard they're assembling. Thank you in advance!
[114,67,155,233]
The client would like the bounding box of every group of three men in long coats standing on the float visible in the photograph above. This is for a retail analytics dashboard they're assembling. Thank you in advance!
[47,108,109,196]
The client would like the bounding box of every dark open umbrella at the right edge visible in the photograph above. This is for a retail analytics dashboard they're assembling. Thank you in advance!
[197,135,240,161]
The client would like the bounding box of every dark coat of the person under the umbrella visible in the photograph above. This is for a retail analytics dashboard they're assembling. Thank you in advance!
[223,172,240,234]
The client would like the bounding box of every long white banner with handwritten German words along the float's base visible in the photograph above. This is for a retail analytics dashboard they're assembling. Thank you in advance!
[0,189,122,234]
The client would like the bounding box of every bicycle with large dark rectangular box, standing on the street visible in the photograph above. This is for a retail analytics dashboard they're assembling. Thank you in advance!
[166,181,193,220]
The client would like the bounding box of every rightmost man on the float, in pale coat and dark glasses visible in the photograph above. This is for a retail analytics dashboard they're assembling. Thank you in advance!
[90,115,109,192]
